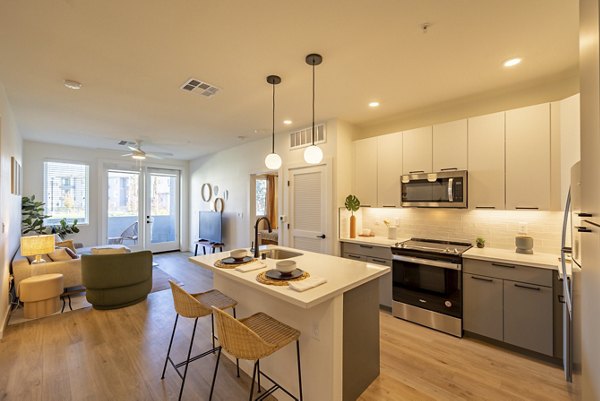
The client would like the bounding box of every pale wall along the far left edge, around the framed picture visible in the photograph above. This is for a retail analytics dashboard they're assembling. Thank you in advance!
[0,83,25,338]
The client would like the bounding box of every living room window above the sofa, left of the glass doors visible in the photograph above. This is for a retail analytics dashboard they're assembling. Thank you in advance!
[44,162,90,224]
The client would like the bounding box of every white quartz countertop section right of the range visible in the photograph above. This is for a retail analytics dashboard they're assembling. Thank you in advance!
[463,247,560,270]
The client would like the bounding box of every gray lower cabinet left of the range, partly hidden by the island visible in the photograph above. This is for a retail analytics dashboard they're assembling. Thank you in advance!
[342,242,392,308]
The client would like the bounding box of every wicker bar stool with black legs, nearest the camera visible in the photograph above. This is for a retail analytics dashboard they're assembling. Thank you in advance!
[209,306,303,401]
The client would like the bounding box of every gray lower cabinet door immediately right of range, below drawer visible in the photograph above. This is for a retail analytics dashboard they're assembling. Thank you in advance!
[463,273,504,341]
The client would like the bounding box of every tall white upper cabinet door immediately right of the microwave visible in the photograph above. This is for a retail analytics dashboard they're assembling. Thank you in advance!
[468,112,504,209]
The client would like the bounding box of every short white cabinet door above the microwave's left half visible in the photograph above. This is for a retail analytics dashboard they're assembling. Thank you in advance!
[402,126,432,174]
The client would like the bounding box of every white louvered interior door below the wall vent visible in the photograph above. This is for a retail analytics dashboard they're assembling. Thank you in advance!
[289,165,330,253]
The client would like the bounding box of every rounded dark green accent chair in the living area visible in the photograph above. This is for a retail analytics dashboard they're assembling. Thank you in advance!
[81,251,152,309]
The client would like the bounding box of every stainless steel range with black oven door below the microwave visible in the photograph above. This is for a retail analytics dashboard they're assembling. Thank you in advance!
[392,238,471,337]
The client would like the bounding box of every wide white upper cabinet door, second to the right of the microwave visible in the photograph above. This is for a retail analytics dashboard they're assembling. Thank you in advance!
[506,103,550,210]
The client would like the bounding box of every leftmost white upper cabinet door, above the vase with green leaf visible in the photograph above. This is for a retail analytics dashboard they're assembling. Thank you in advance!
[353,137,377,207]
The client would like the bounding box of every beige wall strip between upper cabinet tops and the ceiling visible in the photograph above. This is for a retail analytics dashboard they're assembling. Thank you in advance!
[354,70,579,139]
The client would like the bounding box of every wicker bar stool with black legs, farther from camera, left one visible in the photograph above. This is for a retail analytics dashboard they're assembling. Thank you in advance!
[160,280,240,400]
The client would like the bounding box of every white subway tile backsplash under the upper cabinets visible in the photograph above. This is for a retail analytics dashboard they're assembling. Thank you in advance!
[357,208,562,253]
